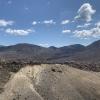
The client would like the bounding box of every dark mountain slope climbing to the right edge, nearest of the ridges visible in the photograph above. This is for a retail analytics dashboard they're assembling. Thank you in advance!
[45,40,100,71]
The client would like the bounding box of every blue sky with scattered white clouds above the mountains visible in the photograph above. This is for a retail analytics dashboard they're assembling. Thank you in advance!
[0,0,100,47]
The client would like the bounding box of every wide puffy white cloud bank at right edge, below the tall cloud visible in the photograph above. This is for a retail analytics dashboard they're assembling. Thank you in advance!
[73,23,100,38]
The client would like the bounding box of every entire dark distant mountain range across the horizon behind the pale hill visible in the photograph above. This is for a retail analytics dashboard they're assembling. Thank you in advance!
[0,40,100,63]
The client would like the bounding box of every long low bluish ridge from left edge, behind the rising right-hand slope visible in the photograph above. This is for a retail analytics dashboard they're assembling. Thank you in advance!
[0,43,85,62]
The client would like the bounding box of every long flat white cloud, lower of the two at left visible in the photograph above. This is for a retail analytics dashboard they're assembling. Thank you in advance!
[5,28,35,36]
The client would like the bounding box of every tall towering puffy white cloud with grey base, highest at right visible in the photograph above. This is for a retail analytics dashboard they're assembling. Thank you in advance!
[75,3,96,22]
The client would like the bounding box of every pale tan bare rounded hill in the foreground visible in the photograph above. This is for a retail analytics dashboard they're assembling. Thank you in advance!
[0,64,100,100]
